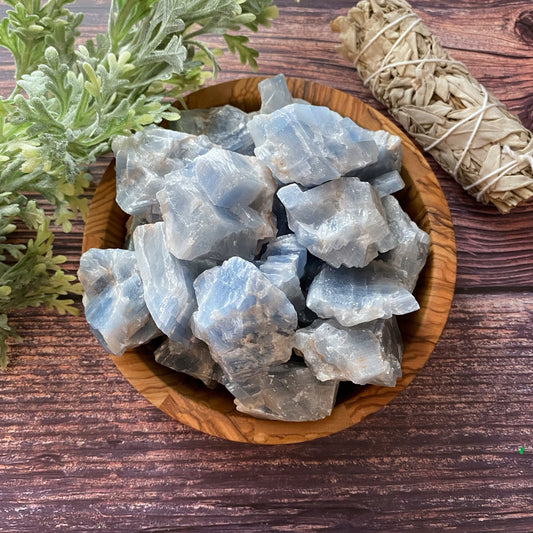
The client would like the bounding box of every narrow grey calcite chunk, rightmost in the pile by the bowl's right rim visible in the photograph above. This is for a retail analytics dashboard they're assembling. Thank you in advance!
[382,196,431,291]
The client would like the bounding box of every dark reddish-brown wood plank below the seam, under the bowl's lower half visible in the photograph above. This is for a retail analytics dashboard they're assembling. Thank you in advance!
[0,294,533,533]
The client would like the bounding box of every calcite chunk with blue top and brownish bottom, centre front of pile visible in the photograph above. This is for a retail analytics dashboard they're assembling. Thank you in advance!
[191,257,297,383]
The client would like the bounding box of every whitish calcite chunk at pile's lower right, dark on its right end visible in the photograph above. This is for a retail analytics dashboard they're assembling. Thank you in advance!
[294,318,403,387]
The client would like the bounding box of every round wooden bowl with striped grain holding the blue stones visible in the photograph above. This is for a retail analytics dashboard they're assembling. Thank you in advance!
[83,78,456,444]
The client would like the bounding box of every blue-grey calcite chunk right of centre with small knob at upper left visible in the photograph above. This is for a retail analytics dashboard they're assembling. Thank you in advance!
[277,178,396,267]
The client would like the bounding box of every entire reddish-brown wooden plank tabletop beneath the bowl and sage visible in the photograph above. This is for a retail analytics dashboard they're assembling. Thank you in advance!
[0,0,533,533]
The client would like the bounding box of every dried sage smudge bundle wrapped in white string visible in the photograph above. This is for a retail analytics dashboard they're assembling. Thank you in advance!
[331,0,533,213]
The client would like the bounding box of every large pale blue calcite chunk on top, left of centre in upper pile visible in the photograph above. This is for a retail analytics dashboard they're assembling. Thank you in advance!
[157,149,275,261]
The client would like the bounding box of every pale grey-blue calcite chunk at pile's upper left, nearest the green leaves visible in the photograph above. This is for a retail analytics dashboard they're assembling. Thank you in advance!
[112,126,213,215]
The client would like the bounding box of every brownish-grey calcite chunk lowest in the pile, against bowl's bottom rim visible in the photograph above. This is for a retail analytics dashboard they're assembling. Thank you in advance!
[224,362,339,422]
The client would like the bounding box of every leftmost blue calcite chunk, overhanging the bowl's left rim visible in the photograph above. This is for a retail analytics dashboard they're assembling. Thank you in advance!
[78,248,160,355]
